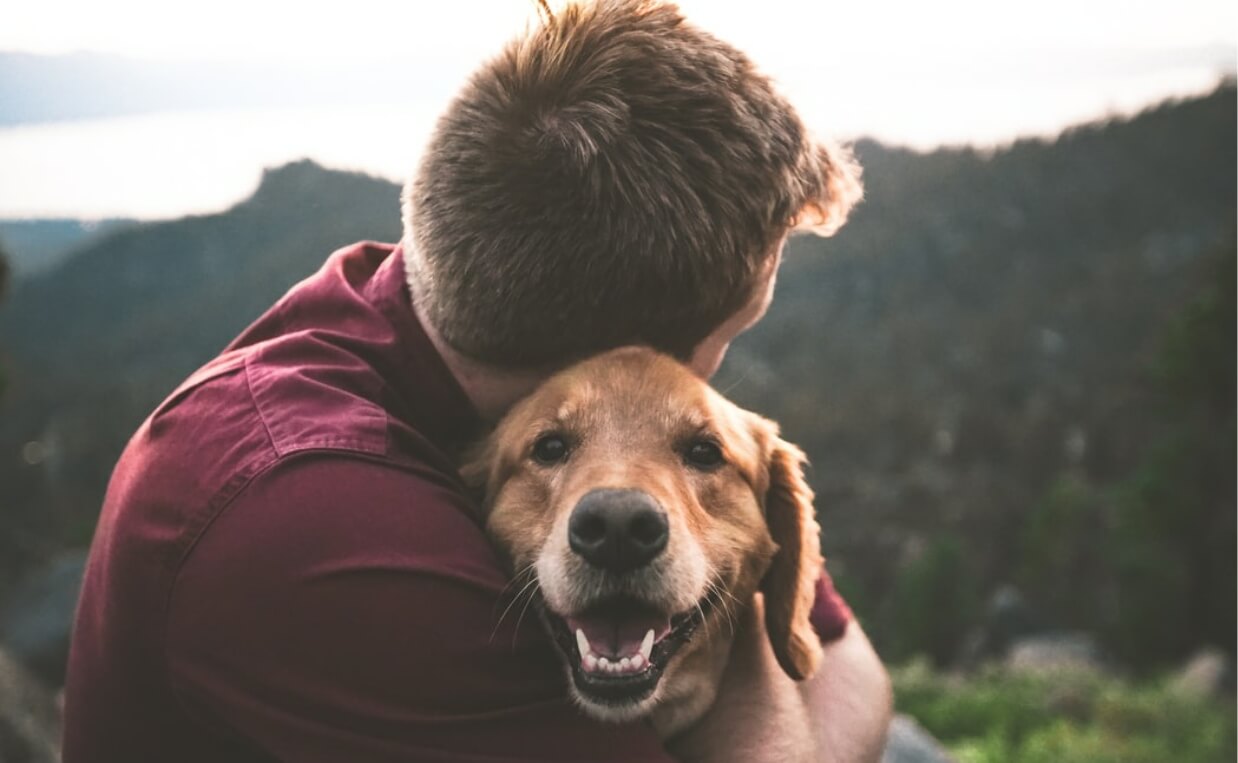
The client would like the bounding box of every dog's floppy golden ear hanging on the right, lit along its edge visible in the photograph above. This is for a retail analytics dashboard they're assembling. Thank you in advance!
[761,437,823,681]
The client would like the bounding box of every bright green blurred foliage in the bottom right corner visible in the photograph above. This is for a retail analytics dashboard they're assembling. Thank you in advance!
[893,663,1236,763]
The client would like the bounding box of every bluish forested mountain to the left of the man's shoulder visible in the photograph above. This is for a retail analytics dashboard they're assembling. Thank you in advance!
[0,161,400,577]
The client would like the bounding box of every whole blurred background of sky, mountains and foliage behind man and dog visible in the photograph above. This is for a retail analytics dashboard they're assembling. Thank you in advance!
[0,0,1238,763]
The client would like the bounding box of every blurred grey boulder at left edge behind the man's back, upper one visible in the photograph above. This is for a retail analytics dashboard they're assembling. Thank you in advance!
[0,550,87,683]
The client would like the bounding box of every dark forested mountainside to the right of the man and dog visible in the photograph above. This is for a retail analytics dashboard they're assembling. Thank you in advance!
[719,87,1236,663]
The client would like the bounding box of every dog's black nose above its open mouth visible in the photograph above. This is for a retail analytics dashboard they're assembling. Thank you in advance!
[567,488,670,572]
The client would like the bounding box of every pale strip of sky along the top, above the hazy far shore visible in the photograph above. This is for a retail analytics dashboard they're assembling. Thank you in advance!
[0,0,1238,68]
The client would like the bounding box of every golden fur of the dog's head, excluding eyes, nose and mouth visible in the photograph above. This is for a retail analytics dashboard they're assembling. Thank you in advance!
[463,348,822,736]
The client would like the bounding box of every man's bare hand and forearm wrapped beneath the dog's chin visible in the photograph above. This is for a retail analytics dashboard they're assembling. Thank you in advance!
[669,595,893,763]
